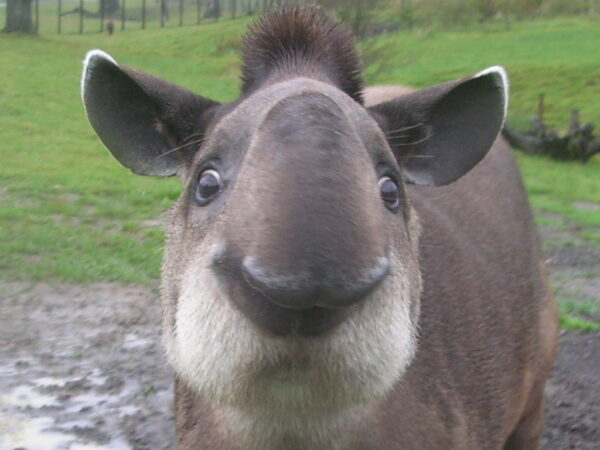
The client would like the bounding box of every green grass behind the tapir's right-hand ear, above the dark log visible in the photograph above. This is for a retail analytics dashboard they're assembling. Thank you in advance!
[367,18,600,128]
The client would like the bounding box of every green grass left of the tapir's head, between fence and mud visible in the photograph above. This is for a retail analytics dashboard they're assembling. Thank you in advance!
[0,20,244,283]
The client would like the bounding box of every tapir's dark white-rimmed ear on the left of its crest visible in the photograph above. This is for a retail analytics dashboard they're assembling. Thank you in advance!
[81,50,218,176]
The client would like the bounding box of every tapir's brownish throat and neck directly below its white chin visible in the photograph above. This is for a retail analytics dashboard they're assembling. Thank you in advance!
[175,381,376,450]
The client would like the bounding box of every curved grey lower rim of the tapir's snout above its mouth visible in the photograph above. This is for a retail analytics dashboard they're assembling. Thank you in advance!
[242,256,390,309]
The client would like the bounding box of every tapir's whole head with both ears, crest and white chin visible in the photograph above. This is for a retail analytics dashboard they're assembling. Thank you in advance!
[82,8,506,414]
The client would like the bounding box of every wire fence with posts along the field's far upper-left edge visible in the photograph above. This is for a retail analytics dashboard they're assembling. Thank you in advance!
[26,0,302,34]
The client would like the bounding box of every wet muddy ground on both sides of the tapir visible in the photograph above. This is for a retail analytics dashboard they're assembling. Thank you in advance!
[0,229,600,450]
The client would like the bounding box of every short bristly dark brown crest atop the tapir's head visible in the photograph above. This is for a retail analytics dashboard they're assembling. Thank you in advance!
[242,6,363,104]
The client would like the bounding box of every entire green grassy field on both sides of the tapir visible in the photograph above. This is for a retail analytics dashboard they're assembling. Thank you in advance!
[0,19,600,320]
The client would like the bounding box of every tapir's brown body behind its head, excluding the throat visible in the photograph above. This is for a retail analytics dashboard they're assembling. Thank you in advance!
[176,135,558,450]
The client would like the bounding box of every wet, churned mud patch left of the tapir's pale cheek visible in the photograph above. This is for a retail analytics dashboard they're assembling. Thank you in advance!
[0,283,175,450]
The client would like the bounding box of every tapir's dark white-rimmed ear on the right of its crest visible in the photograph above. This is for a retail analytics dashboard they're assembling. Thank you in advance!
[369,66,508,186]
